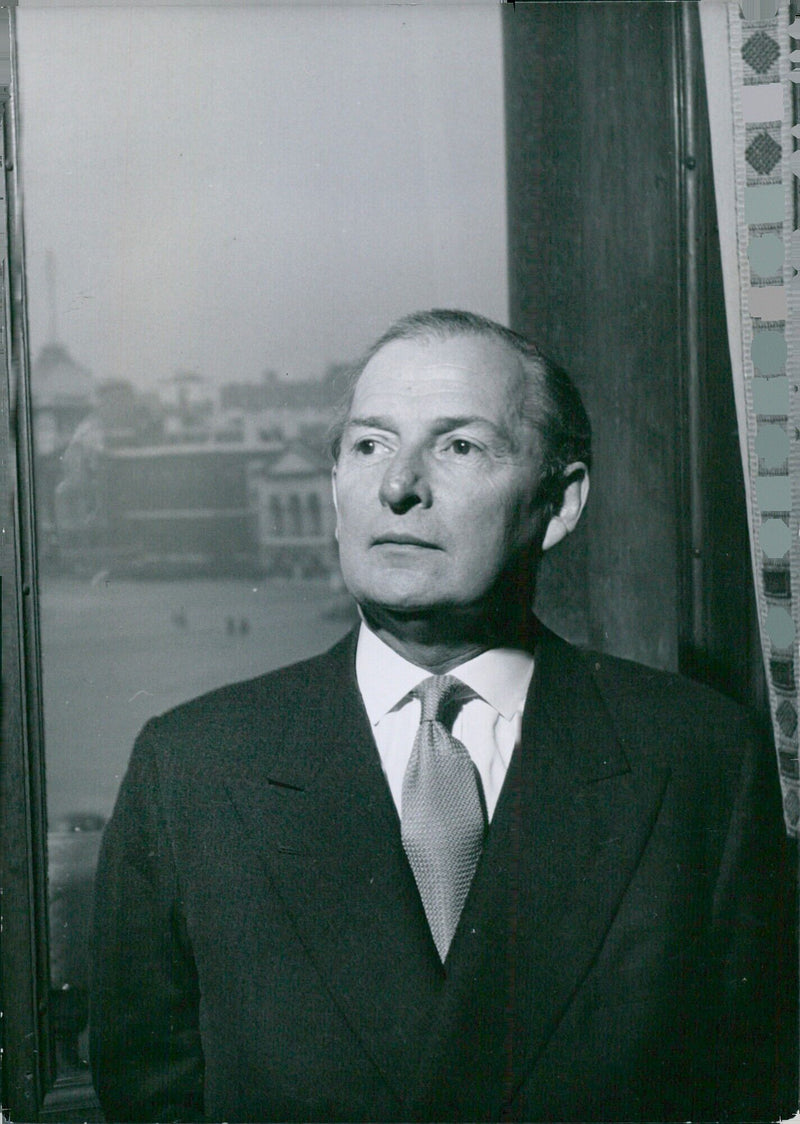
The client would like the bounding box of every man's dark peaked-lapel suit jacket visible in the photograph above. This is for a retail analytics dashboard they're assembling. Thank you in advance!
[92,632,797,1121]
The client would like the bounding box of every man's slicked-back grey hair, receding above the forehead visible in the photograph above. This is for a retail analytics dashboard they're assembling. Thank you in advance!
[328,308,591,499]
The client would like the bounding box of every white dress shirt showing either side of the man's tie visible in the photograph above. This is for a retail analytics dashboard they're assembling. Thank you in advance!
[355,623,534,819]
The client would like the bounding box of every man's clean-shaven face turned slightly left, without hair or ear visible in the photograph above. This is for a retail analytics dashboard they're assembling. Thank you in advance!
[334,336,550,611]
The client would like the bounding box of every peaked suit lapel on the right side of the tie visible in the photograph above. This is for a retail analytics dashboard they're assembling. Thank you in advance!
[407,633,666,1120]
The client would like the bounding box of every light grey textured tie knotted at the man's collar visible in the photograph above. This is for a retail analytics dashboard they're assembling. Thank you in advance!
[401,676,487,962]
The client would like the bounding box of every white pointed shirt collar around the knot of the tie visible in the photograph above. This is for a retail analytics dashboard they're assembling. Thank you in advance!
[355,622,534,726]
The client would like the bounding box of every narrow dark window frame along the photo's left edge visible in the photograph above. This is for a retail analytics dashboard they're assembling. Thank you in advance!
[0,15,102,1122]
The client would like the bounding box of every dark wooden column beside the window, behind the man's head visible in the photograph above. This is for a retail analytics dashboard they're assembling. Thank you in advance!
[503,0,757,696]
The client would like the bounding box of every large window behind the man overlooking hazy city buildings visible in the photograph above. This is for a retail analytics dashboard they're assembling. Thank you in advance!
[0,4,507,1121]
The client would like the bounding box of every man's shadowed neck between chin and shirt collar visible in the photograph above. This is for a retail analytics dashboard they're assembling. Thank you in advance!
[361,606,536,676]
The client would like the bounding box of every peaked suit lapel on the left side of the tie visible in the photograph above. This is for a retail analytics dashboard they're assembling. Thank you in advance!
[226,637,444,1095]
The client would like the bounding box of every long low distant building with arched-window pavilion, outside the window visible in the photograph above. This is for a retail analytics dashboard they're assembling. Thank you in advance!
[56,433,336,578]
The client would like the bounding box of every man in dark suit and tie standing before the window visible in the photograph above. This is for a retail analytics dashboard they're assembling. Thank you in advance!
[92,311,791,1121]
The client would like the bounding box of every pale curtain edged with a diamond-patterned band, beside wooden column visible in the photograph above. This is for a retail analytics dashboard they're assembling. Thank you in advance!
[700,0,800,836]
